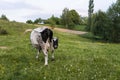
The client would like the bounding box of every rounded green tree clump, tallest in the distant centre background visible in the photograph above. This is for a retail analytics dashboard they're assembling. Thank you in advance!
[61,8,81,29]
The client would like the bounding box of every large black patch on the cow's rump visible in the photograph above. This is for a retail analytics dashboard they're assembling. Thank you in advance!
[40,28,53,43]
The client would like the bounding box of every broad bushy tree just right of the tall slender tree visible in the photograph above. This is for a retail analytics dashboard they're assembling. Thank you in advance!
[91,10,111,41]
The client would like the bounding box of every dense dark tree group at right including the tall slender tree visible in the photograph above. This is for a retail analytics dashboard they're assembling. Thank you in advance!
[86,0,120,42]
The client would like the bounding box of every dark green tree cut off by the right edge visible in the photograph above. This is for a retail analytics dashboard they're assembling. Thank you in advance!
[107,0,120,42]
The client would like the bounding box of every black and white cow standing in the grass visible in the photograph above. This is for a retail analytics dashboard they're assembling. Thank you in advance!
[30,27,58,65]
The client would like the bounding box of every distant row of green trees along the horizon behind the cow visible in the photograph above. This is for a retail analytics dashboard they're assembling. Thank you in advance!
[26,8,87,29]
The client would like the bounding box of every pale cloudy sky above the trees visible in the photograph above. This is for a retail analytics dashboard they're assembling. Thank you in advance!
[0,0,116,22]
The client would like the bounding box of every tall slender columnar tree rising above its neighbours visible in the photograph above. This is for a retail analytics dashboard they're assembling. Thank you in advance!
[86,0,94,31]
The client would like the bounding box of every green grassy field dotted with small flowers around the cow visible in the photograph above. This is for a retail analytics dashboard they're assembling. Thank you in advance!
[0,21,120,80]
